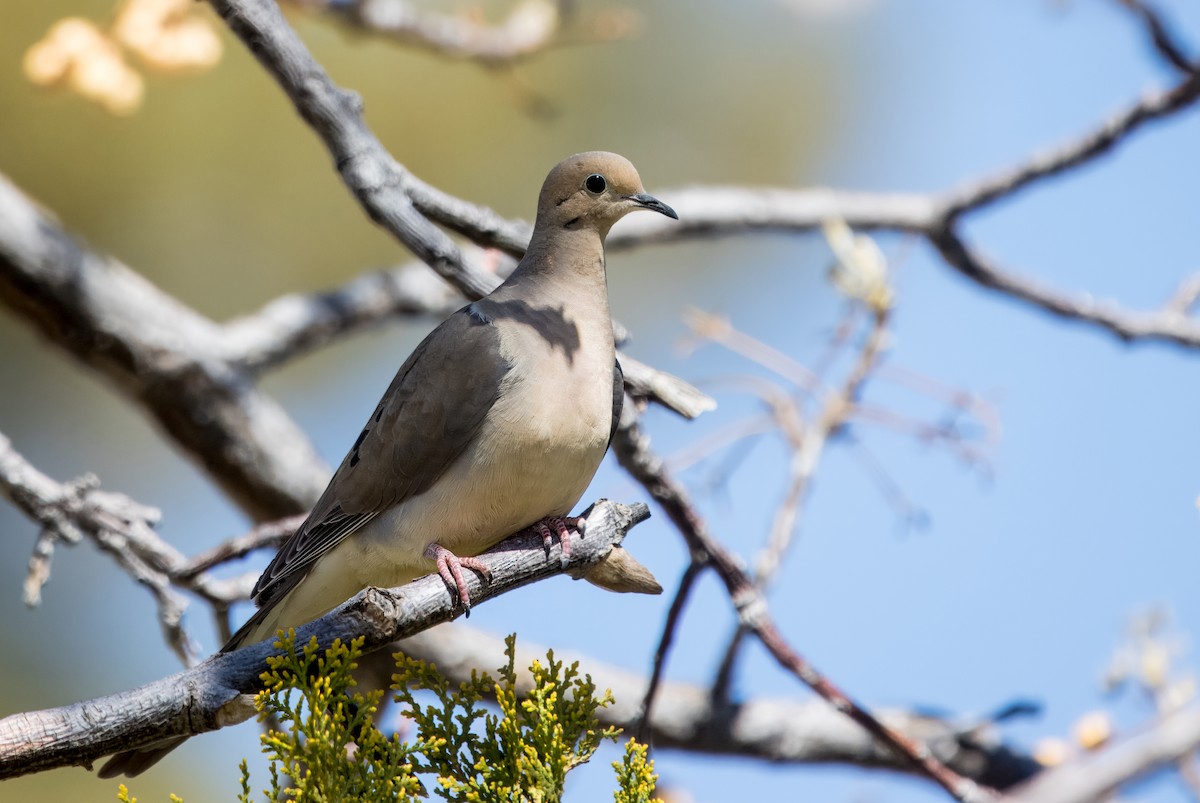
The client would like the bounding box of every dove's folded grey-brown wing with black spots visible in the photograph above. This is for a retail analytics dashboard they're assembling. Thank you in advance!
[253,307,512,609]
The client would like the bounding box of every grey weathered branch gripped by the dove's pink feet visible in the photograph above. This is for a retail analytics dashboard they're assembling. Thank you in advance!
[0,501,649,779]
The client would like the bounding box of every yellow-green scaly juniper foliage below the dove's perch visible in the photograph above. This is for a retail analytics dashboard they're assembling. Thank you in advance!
[118,633,656,803]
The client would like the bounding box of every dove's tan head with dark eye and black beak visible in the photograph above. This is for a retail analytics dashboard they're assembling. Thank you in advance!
[535,150,679,238]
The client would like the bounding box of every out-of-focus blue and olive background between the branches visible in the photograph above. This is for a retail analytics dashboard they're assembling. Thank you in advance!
[0,0,1200,803]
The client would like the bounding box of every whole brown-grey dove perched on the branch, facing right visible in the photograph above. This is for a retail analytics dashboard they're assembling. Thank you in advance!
[100,151,678,778]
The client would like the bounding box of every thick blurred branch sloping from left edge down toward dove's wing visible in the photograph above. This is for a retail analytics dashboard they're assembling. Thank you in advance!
[0,176,329,519]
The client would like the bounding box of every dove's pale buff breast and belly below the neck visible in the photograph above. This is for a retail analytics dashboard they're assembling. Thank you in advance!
[350,284,616,566]
